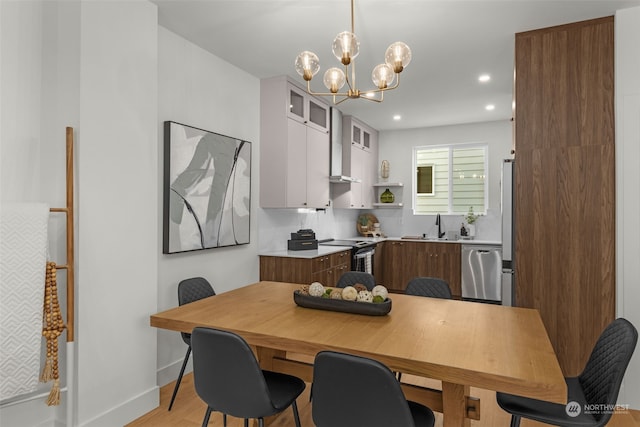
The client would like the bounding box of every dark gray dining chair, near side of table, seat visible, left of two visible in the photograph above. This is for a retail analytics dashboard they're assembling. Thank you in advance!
[191,327,306,427]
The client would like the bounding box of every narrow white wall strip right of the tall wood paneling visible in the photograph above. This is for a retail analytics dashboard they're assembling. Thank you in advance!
[615,7,640,409]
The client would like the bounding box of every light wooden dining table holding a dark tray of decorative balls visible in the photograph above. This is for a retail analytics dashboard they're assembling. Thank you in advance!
[150,281,567,427]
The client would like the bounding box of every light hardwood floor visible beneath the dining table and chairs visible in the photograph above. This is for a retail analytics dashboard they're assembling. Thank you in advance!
[126,374,640,427]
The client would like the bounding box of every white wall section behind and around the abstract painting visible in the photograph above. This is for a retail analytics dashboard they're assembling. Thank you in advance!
[155,27,260,385]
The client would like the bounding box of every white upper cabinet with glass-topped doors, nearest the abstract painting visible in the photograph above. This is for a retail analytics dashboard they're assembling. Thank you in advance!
[260,76,330,208]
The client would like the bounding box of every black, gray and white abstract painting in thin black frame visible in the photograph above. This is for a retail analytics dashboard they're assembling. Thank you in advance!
[163,121,251,254]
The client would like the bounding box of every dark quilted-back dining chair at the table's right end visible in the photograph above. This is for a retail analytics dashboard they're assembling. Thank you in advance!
[496,318,638,427]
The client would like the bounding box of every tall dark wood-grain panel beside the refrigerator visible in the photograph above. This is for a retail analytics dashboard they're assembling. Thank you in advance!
[515,17,616,376]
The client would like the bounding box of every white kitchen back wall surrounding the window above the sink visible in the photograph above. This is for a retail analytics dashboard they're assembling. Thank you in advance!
[375,120,512,241]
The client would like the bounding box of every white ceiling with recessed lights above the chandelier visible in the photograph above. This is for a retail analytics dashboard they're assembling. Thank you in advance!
[152,0,640,130]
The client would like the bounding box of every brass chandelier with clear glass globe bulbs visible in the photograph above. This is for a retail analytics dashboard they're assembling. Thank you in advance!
[295,0,411,104]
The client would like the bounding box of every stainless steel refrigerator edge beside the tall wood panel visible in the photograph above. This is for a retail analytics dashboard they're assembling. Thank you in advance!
[500,159,516,306]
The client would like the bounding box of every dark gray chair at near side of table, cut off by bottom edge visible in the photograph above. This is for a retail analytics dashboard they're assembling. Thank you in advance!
[312,351,435,427]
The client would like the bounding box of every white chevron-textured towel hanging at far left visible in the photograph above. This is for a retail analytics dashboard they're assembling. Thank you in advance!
[0,203,49,400]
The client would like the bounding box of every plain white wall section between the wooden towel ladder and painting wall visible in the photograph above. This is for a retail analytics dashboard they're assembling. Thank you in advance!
[77,1,158,426]
